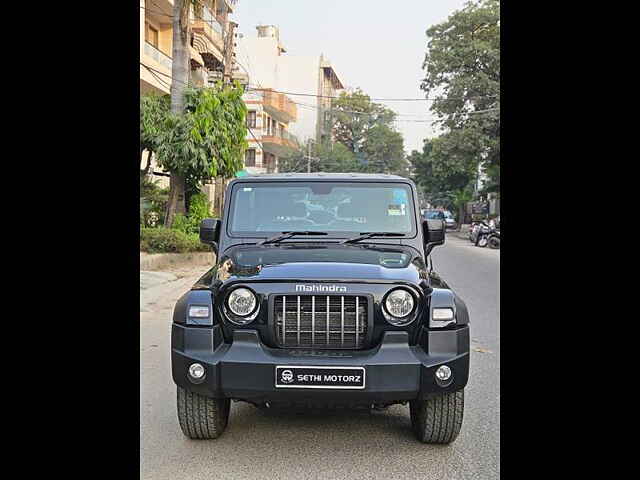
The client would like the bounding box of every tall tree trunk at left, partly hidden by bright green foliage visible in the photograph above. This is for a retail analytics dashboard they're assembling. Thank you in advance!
[164,0,191,228]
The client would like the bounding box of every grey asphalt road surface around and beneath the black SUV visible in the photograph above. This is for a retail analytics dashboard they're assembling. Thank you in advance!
[140,234,500,480]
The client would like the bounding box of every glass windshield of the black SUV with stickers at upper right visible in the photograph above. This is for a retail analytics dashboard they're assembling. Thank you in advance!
[228,181,415,236]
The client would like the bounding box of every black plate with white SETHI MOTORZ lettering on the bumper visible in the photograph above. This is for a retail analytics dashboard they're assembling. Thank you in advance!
[275,365,366,390]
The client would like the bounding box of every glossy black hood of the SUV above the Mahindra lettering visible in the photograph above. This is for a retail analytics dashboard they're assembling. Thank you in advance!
[199,244,427,285]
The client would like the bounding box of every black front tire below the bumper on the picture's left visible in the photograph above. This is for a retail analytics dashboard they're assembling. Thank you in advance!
[178,387,231,440]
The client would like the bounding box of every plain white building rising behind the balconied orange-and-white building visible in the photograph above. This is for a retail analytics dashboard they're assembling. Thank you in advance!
[236,25,344,144]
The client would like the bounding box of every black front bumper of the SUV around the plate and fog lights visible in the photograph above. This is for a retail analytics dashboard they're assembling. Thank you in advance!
[171,323,469,405]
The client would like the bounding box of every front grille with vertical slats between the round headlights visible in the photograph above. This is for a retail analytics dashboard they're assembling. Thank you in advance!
[273,295,368,349]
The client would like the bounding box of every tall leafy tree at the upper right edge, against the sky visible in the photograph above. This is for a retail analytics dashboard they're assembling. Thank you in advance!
[420,0,500,188]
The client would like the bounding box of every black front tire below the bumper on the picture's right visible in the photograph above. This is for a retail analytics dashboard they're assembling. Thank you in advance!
[409,389,464,444]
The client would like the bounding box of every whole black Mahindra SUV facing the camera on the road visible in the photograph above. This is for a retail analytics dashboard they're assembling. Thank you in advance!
[171,173,469,443]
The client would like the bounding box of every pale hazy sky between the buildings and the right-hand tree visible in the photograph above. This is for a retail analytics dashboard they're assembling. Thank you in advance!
[231,0,466,153]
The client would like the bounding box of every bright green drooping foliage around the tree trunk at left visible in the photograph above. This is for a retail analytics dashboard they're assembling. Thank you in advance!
[156,84,247,185]
